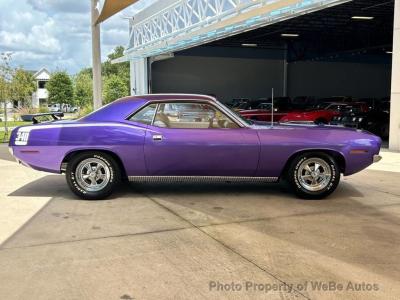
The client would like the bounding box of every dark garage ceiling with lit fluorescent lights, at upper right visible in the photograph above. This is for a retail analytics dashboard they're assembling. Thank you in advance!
[212,0,394,62]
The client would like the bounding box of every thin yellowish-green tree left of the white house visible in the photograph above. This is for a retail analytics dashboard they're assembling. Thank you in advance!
[11,68,36,106]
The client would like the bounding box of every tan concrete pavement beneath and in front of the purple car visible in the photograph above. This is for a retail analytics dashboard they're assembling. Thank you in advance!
[0,145,400,299]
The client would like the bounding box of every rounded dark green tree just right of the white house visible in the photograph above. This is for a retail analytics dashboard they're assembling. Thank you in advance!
[46,71,74,105]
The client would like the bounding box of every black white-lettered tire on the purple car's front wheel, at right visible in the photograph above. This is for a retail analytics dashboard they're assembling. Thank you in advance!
[286,152,340,199]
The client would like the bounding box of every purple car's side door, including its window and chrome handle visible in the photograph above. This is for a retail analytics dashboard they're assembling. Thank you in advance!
[144,101,260,176]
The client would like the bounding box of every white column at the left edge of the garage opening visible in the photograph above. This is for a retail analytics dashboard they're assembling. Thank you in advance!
[130,58,149,95]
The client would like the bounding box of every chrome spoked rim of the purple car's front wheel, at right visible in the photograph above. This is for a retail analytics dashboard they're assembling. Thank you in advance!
[297,158,332,192]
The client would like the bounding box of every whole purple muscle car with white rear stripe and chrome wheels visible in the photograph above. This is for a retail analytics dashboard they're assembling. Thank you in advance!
[10,94,381,199]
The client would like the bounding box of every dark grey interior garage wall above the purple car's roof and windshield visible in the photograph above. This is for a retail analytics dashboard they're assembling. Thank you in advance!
[151,48,283,101]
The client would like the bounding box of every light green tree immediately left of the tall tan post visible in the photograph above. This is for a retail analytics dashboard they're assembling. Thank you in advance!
[74,71,93,108]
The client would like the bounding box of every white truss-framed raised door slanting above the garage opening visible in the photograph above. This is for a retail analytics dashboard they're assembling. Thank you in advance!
[119,0,350,62]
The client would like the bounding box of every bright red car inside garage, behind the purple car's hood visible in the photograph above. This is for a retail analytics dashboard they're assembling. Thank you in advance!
[280,102,369,124]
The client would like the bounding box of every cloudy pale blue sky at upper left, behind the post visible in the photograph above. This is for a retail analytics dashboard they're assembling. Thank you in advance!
[0,0,156,74]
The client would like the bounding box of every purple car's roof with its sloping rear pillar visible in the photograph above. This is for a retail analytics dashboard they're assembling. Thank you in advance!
[80,94,217,122]
